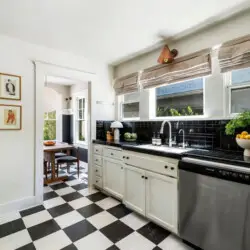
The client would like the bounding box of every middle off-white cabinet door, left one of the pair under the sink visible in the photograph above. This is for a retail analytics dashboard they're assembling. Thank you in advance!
[123,165,146,215]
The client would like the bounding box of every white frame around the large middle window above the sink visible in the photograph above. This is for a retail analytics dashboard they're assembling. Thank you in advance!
[150,77,206,121]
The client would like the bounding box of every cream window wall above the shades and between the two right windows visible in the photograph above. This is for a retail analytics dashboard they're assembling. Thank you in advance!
[114,11,250,120]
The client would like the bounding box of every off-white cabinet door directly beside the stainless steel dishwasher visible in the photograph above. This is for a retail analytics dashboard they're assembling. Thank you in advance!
[146,171,178,233]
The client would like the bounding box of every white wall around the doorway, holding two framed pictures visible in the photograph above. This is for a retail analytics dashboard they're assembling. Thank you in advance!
[0,35,114,214]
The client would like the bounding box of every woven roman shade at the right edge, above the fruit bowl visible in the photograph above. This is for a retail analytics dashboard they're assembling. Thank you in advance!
[218,35,250,72]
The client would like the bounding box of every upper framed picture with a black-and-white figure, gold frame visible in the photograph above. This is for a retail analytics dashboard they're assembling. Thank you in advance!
[0,73,22,100]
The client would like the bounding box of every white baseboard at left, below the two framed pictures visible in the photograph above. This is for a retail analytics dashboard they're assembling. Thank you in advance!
[0,196,42,214]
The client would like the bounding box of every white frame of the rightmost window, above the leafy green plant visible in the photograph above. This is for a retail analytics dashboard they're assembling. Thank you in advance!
[223,68,250,118]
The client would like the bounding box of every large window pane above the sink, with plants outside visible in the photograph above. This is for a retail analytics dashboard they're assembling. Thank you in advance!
[155,78,204,117]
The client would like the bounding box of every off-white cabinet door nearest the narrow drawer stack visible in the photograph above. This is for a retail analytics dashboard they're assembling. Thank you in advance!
[103,157,124,199]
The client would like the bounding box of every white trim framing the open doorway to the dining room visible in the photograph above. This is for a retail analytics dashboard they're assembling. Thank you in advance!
[34,61,94,204]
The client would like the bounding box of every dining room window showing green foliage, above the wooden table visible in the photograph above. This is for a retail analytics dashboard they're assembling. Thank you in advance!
[43,110,56,141]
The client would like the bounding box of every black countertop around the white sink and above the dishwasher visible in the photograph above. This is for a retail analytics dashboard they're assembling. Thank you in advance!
[93,140,250,168]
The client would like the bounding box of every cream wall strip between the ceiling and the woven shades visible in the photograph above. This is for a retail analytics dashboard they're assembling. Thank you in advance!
[114,11,250,78]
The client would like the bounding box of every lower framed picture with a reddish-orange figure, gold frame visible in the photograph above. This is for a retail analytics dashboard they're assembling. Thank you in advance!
[0,104,22,130]
